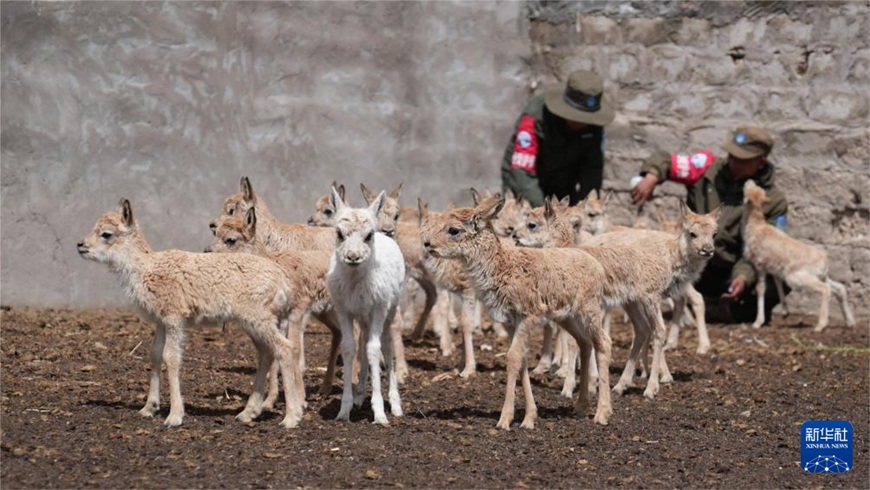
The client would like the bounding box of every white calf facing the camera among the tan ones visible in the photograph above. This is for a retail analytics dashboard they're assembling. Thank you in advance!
[327,189,405,425]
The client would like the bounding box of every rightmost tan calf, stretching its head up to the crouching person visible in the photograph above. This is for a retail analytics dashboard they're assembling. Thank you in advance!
[743,180,855,332]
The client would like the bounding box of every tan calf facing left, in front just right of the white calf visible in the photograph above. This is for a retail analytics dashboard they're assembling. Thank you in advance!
[421,194,613,430]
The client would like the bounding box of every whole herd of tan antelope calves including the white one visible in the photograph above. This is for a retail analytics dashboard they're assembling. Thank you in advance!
[78,177,854,430]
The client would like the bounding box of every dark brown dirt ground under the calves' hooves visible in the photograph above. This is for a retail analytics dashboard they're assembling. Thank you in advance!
[0,308,870,488]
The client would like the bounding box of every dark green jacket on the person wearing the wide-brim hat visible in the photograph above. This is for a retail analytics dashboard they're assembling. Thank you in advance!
[501,94,604,206]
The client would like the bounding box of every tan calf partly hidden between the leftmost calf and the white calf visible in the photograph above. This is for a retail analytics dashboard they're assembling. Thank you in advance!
[206,208,341,408]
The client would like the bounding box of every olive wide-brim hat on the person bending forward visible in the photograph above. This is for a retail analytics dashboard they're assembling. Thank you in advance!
[544,71,616,126]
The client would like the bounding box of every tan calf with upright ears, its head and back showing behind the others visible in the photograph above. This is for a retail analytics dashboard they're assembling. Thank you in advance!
[209,177,335,252]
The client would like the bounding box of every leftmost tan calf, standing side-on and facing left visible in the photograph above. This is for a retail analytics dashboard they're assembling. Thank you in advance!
[78,199,302,428]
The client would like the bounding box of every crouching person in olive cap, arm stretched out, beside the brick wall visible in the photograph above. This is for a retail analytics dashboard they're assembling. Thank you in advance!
[631,126,788,322]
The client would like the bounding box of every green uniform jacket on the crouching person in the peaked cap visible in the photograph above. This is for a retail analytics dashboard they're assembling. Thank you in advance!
[640,151,788,289]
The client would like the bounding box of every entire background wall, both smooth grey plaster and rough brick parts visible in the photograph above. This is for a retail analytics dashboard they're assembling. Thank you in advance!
[0,1,870,318]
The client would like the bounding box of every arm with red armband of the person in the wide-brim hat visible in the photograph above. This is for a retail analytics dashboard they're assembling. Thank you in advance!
[501,114,544,207]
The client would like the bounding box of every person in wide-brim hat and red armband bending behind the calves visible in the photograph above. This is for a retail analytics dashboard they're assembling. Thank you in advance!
[501,71,614,206]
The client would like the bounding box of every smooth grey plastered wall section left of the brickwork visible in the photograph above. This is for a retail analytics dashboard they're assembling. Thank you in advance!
[0,2,529,307]
